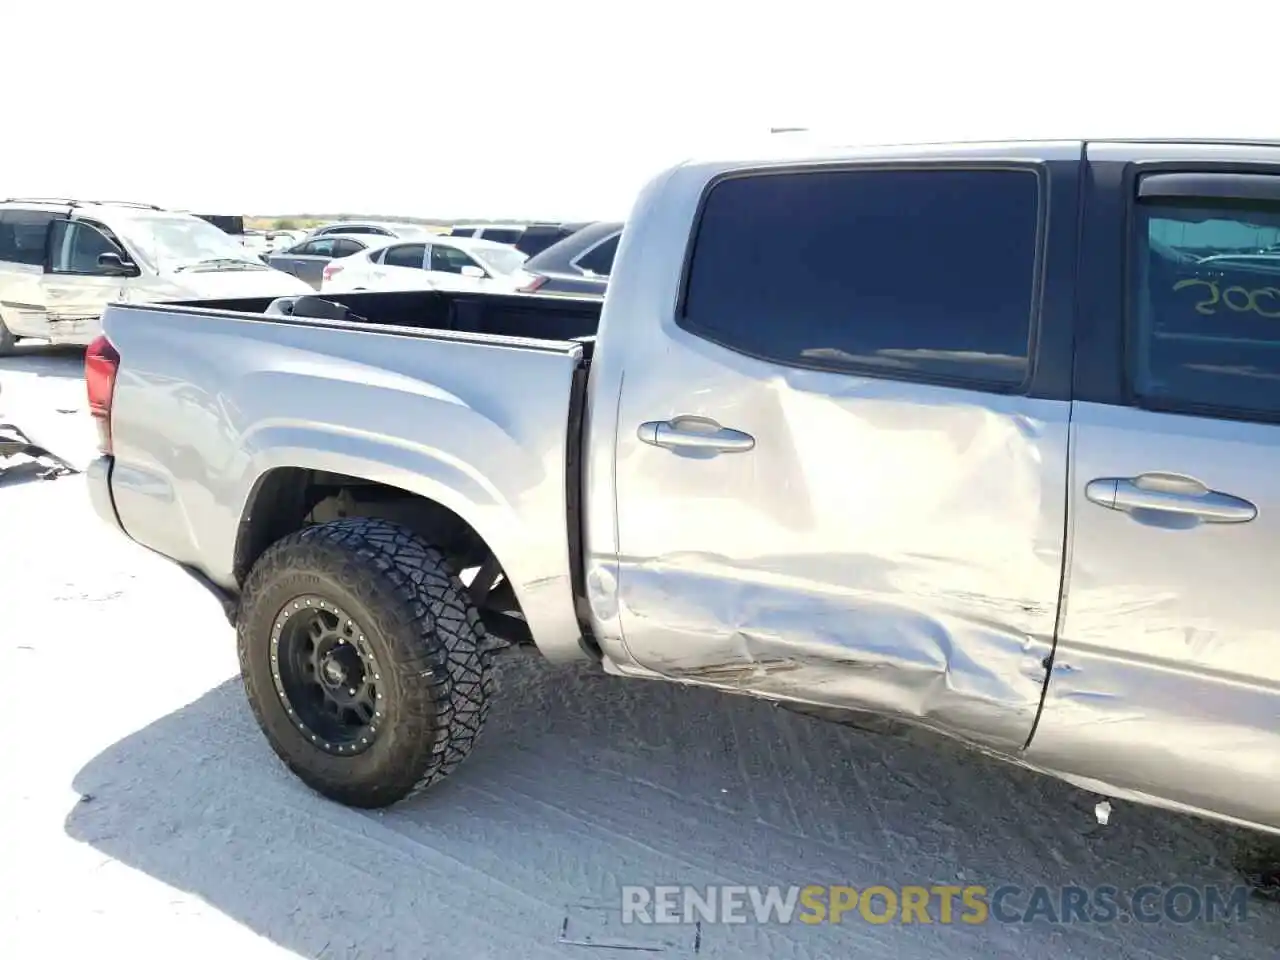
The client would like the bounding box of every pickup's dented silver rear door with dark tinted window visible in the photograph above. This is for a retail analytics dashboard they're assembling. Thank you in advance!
[606,146,1079,750]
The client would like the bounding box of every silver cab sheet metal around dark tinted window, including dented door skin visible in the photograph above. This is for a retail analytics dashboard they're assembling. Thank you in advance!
[586,143,1080,754]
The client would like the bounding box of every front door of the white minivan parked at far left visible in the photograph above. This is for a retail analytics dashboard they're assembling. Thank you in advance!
[44,220,137,340]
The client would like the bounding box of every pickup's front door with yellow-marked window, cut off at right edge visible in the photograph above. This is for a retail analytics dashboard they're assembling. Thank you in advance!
[1030,146,1280,827]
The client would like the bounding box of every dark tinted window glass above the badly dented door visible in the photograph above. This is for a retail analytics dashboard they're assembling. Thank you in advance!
[677,166,1043,392]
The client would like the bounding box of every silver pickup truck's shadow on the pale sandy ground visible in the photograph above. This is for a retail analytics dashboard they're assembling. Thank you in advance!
[65,653,1280,960]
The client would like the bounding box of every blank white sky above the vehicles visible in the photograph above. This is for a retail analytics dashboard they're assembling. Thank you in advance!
[10,0,1280,219]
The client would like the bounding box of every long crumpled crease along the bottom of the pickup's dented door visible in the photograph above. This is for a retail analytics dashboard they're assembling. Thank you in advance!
[616,556,1043,719]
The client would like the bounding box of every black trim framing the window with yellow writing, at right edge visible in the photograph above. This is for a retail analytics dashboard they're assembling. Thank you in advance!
[1120,160,1280,424]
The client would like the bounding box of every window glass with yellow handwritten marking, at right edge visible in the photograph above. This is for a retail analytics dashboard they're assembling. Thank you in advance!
[1126,174,1280,420]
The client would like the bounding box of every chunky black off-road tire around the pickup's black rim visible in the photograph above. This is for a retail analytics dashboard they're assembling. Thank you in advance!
[236,517,494,809]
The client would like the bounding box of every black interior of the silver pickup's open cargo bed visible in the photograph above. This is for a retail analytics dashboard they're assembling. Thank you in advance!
[156,291,602,340]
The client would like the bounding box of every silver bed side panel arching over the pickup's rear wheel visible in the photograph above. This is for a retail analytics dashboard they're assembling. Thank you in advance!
[105,306,581,657]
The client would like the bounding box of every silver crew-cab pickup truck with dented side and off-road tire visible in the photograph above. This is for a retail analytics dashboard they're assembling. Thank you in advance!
[86,141,1280,833]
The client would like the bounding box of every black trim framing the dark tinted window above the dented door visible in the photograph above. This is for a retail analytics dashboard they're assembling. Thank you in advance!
[673,159,1049,399]
